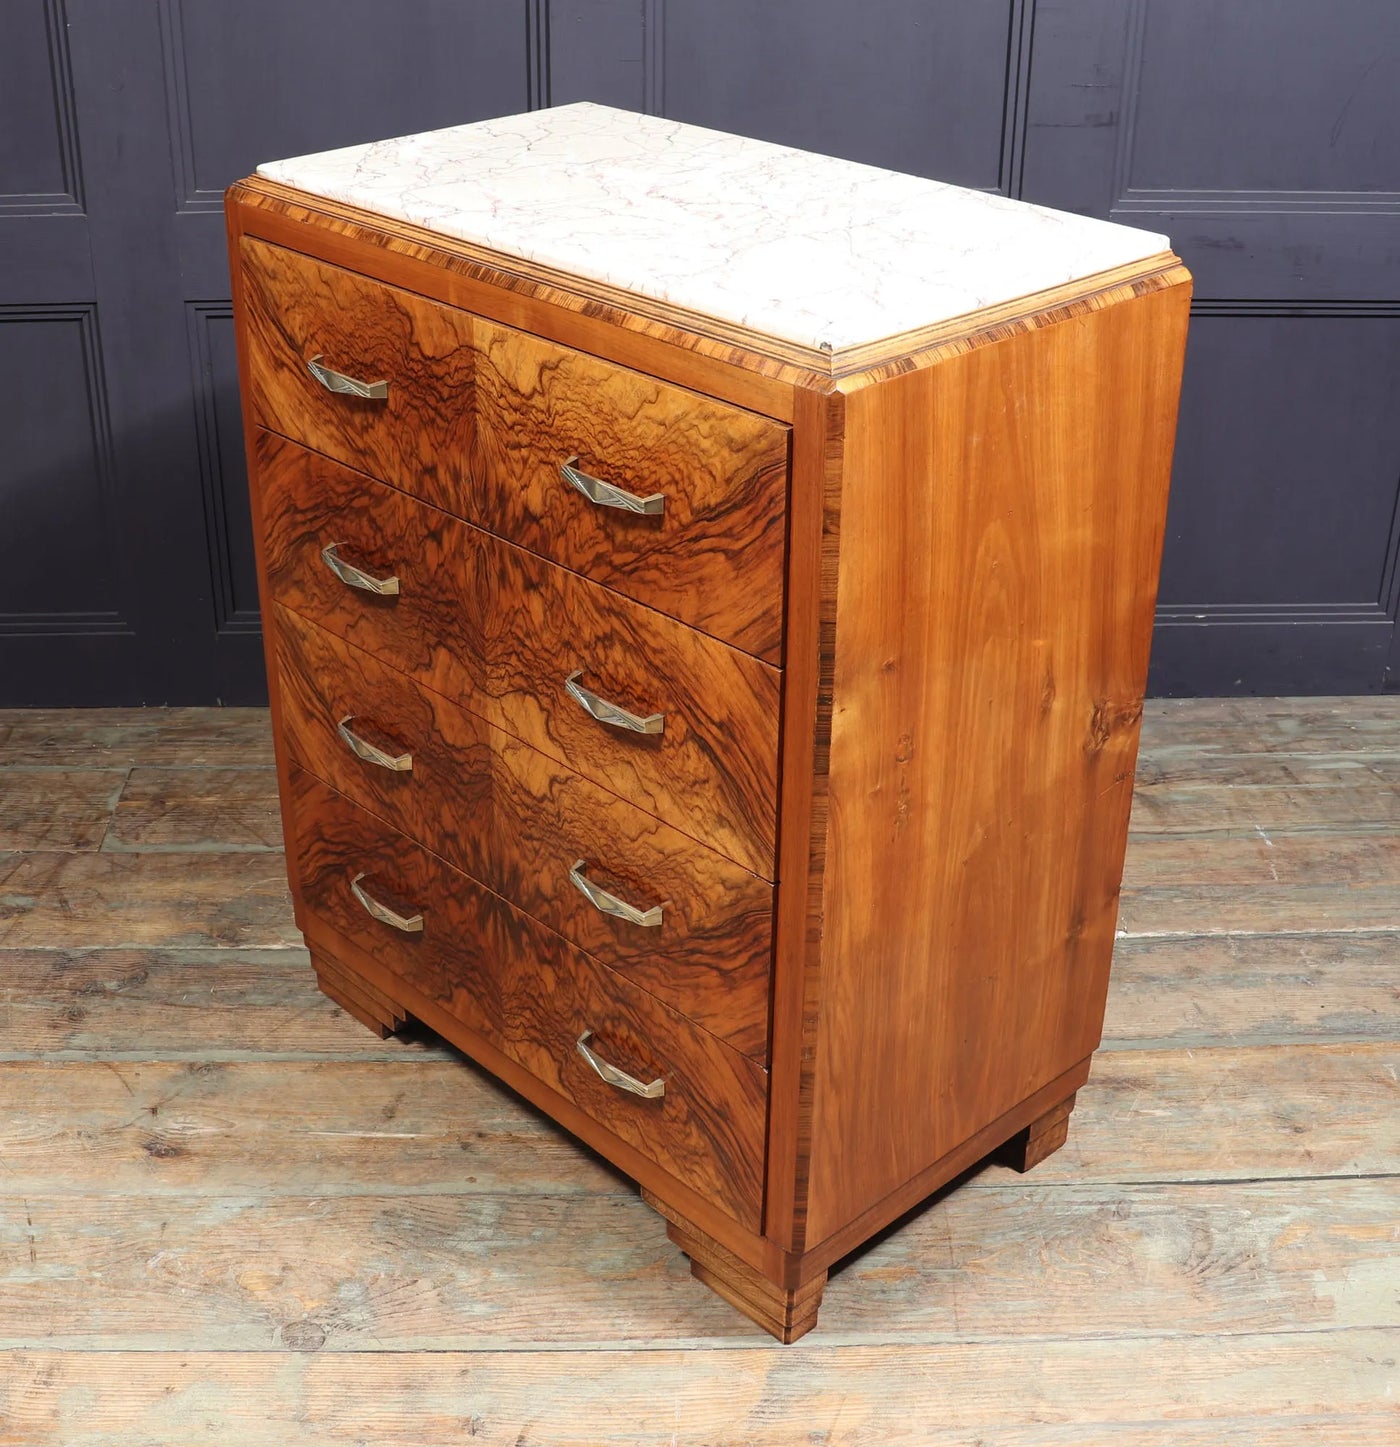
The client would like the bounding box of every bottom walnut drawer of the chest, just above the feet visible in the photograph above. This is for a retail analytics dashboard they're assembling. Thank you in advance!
[291,768,768,1231]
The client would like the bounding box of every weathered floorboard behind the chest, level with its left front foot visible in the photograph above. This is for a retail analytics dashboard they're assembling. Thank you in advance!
[0,935,1400,1059]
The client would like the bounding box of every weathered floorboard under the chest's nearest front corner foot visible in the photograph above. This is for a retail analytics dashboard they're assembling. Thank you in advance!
[8,1181,1400,1348]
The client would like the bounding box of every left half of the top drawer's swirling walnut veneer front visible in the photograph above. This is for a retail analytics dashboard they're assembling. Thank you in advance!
[239,237,476,495]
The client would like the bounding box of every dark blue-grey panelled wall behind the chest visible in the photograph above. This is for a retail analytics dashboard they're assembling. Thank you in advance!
[0,0,1400,705]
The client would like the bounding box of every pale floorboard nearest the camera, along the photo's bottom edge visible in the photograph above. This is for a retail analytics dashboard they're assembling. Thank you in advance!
[0,1328,1400,1447]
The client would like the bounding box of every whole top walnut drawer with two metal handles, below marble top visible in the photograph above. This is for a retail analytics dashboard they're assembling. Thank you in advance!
[240,237,788,663]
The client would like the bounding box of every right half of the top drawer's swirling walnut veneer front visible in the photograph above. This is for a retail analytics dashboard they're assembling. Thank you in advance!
[474,321,788,663]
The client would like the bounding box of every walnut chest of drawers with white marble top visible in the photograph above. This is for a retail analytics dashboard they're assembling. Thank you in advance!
[229,106,1189,1340]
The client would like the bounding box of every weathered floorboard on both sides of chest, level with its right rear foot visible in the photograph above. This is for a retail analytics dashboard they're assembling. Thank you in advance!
[0,1036,1400,1200]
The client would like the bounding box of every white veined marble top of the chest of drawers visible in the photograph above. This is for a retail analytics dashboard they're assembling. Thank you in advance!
[257,103,1169,352]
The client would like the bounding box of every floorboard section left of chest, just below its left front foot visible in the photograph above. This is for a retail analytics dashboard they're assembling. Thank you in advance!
[0,1053,624,1202]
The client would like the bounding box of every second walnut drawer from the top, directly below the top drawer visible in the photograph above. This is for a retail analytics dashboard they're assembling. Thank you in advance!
[256,431,780,880]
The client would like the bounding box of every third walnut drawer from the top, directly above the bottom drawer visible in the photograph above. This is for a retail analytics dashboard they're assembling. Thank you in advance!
[269,606,772,1059]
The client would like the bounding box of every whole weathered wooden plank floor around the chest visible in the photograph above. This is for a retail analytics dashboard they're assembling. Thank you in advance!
[0,697,1400,1447]
